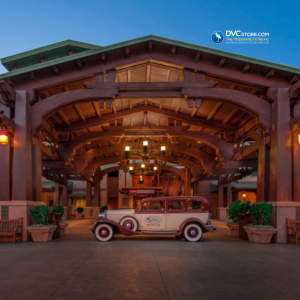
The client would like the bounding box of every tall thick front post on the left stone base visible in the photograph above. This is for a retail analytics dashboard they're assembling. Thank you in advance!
[12,91,32,200]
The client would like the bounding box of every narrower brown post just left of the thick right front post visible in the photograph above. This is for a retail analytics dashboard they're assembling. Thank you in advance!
[256,137,270,202]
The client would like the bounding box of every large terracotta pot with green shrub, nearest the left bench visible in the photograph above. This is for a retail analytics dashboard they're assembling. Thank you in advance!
[27,205,57,242]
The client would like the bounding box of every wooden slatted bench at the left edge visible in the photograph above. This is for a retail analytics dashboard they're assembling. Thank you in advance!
[0,218,23,244]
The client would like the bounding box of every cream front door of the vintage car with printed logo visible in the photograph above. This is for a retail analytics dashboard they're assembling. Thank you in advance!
[136,200,166,231]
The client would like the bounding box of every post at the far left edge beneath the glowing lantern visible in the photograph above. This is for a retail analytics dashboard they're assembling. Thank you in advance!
[0,136,12,201]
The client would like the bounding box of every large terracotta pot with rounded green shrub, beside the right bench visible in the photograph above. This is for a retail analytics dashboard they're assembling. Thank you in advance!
[244,202,277,244]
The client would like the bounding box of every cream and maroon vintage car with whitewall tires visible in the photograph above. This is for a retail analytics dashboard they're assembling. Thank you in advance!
[91,196,214,242]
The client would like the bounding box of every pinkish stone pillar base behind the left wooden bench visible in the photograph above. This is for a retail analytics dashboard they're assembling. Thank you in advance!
[0,200,46,242]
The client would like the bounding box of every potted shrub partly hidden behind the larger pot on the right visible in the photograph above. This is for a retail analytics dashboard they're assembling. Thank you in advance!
[227,200,251,237]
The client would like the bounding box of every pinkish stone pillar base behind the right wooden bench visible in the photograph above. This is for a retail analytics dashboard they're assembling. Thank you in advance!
[268,201,300,244]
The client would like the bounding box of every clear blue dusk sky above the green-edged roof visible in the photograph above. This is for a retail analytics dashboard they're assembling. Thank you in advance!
[0,0,300,73]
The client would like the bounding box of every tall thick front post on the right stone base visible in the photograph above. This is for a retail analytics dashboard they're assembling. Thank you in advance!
[269,88,292,201]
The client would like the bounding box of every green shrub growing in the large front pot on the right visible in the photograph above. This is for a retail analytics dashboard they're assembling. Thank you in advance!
[250,202,272,226]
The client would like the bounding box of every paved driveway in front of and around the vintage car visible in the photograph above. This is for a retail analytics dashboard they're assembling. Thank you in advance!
[0,220,300,300]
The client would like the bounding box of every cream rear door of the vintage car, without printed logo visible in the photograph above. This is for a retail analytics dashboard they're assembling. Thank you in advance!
[166,200,186,231]
